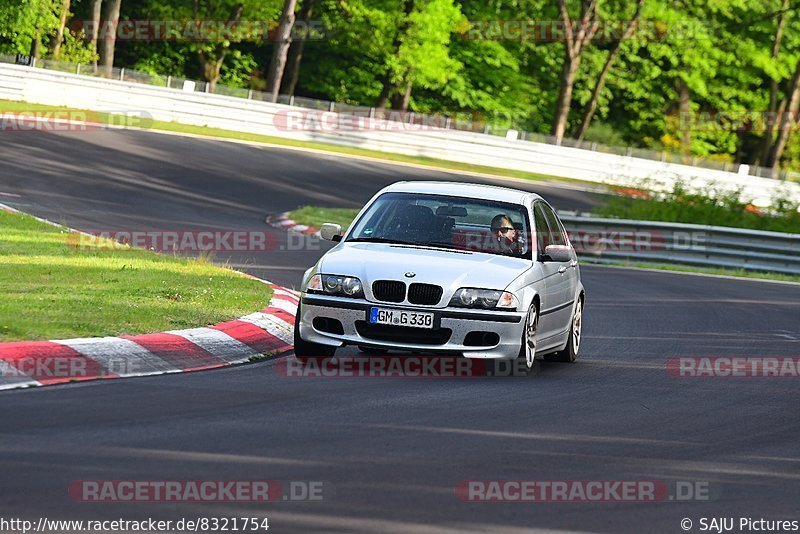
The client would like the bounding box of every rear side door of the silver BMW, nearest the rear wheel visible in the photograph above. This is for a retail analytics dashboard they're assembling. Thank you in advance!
[540,202,578,334]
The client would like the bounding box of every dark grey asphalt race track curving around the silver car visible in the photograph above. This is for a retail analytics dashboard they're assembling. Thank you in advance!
[0,132,800,533]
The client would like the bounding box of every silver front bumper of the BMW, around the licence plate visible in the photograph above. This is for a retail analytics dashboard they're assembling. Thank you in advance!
[299,294,525,359]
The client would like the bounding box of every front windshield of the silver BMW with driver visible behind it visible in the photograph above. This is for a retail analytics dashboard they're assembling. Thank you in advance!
[347,193,531,259]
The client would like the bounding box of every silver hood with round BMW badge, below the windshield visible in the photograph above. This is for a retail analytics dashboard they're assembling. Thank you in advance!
[317,243,531,302]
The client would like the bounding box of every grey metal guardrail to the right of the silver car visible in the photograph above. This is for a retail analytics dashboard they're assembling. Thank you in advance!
[559,216,800,275]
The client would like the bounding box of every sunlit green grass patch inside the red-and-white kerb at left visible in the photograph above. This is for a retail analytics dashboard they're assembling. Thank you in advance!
[0,211,272,342]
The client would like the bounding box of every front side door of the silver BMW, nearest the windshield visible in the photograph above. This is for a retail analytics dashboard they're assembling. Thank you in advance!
[533,201,565,339]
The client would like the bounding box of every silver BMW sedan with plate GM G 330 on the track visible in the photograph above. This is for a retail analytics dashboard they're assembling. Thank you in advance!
[294,182,584,370]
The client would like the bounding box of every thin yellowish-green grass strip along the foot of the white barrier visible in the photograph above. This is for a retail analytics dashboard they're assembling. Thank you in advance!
[0,100,568,186]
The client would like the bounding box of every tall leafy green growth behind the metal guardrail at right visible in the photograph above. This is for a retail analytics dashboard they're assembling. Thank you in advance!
[593,183,800,233]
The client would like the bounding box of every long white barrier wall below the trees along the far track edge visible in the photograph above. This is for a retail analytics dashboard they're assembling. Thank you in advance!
[0,63,800,206]
